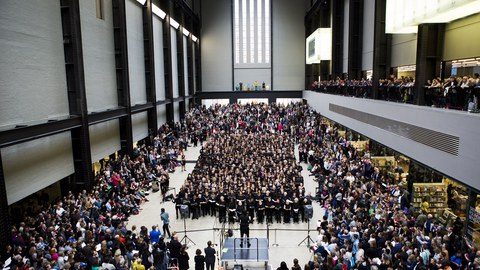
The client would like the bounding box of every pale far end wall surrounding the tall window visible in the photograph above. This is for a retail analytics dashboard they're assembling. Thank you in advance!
[201,0,306,92]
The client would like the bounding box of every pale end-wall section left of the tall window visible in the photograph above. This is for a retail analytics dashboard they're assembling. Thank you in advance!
[200,0,233,92]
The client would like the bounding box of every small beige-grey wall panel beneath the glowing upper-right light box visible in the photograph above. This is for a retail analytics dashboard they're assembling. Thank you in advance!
[390,34,417,67]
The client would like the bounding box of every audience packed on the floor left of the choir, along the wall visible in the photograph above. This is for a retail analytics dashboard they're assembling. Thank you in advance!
[0,120,196,270]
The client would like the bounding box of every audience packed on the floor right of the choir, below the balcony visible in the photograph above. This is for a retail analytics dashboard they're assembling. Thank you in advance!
[299,110,480,270]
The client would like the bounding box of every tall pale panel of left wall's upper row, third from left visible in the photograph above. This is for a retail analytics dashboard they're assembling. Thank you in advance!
[125,0,147,105]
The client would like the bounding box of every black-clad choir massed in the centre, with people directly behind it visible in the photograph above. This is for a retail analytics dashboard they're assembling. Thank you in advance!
[175,101,312,223]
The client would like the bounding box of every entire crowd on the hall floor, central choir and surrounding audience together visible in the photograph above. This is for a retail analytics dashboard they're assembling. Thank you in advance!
[1,103,480,270]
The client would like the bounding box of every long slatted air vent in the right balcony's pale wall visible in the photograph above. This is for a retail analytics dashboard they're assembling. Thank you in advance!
[329,103,460,156]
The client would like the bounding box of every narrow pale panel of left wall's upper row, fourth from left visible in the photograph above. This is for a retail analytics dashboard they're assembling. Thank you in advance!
[153,16,169,100]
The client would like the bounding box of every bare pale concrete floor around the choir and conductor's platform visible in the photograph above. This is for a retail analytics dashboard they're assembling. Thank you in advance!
[128,141,324,270]
